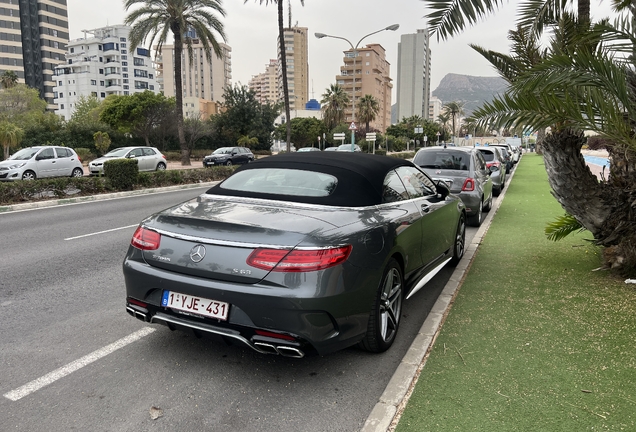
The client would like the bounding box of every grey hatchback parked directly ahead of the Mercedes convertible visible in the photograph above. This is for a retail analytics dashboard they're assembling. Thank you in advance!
[413,147,492,226]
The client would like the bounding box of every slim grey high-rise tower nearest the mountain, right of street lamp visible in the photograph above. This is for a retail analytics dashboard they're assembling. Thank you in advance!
[397,29,431,122]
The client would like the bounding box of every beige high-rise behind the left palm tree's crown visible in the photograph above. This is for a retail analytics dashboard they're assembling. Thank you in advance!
[156,37,232,102]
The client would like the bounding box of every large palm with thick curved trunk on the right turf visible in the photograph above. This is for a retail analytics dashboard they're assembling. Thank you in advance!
[420,0,636,274]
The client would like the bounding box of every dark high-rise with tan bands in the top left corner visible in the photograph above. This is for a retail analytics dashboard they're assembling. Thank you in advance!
[0,0,69,109]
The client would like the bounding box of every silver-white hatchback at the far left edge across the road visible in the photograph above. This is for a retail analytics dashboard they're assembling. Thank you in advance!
[0,146,84,181]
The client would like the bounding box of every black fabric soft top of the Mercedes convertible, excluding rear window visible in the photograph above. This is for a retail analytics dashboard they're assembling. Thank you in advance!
[207,152,415,207]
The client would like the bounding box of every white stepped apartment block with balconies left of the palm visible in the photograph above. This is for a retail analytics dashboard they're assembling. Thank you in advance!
[54,25,159,119]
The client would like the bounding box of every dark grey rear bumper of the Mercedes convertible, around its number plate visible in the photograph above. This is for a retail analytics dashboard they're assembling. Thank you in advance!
[123,258,375,357]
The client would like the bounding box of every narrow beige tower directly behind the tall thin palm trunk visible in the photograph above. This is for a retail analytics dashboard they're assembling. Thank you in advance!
[277,27,309,110]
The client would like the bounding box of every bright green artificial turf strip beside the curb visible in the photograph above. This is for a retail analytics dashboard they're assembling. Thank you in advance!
[396,153,636,432]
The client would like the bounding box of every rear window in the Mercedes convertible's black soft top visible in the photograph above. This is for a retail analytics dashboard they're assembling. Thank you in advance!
[219,168,338,197]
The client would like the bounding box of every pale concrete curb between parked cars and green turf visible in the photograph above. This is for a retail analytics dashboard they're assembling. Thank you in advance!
[360,159,516,432]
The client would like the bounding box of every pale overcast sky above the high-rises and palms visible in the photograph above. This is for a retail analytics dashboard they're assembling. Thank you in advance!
[67,0,609,102]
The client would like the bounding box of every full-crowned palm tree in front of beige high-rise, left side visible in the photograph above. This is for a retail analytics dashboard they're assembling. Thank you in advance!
[124,0,226,165]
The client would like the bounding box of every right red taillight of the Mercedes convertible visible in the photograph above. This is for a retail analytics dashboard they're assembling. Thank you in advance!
[247,245,351,272]
